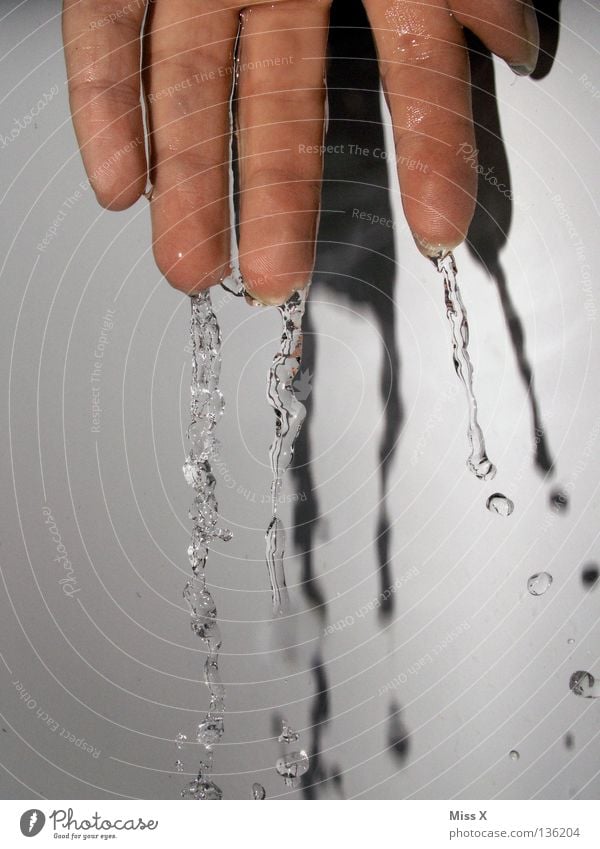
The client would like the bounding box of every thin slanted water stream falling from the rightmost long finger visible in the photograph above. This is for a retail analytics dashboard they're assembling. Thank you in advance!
[434,252,496,481]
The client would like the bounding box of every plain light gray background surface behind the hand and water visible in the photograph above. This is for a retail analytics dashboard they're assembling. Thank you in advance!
[0,1,600,799]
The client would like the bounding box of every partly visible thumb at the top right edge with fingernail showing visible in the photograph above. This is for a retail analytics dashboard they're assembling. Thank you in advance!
[450,0,540,75]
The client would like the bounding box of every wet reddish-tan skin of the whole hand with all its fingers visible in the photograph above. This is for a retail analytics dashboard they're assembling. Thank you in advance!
[63,0,539,304]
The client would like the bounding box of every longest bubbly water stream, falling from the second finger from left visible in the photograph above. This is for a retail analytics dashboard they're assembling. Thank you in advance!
[177,292,232,799]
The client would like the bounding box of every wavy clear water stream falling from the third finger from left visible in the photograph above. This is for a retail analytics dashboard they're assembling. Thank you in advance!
[265,289,308,616]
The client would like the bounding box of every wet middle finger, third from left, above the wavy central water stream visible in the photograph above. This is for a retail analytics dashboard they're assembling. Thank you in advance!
[238,0,329,303]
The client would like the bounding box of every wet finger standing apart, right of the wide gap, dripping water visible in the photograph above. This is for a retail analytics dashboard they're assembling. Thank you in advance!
[365,0,477,256]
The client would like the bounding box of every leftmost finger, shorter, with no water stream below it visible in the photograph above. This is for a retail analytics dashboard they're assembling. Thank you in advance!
[62,0,146,209]
